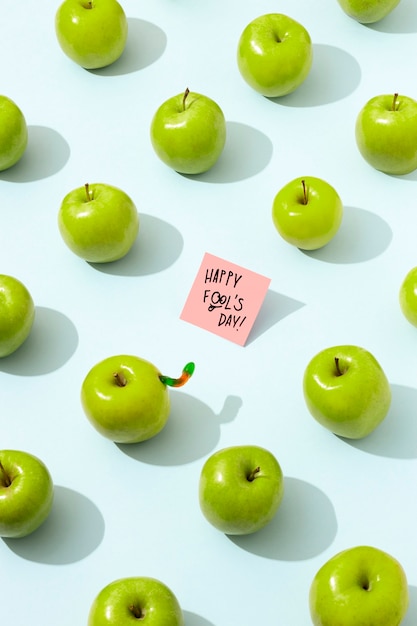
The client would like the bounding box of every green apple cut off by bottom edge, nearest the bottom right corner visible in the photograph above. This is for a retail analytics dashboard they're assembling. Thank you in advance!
[309,546,409,626]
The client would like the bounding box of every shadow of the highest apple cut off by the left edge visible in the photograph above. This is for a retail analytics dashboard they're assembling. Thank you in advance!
[0,126,70,183]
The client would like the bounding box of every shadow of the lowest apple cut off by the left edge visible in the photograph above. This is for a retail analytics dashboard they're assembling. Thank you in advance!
[3,486,105,565]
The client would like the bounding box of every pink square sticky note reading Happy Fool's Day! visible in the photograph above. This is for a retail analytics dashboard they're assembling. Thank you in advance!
[180,252,271,346]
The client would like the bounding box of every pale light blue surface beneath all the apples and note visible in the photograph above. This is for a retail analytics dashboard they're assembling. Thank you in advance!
[0,0,417,626]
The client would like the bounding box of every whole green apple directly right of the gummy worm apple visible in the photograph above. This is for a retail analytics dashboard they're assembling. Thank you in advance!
[303,345,391,439]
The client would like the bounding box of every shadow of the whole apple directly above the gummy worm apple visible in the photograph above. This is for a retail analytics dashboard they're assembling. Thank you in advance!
[89,214,184,276]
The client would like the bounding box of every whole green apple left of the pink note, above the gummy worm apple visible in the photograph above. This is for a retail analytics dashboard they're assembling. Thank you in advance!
[58,183,139,263]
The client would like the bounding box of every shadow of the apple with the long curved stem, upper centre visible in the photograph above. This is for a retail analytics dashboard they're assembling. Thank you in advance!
[181,121,273,184]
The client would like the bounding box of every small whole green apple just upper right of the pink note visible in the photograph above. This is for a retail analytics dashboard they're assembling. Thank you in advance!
[272,176,343,250]
